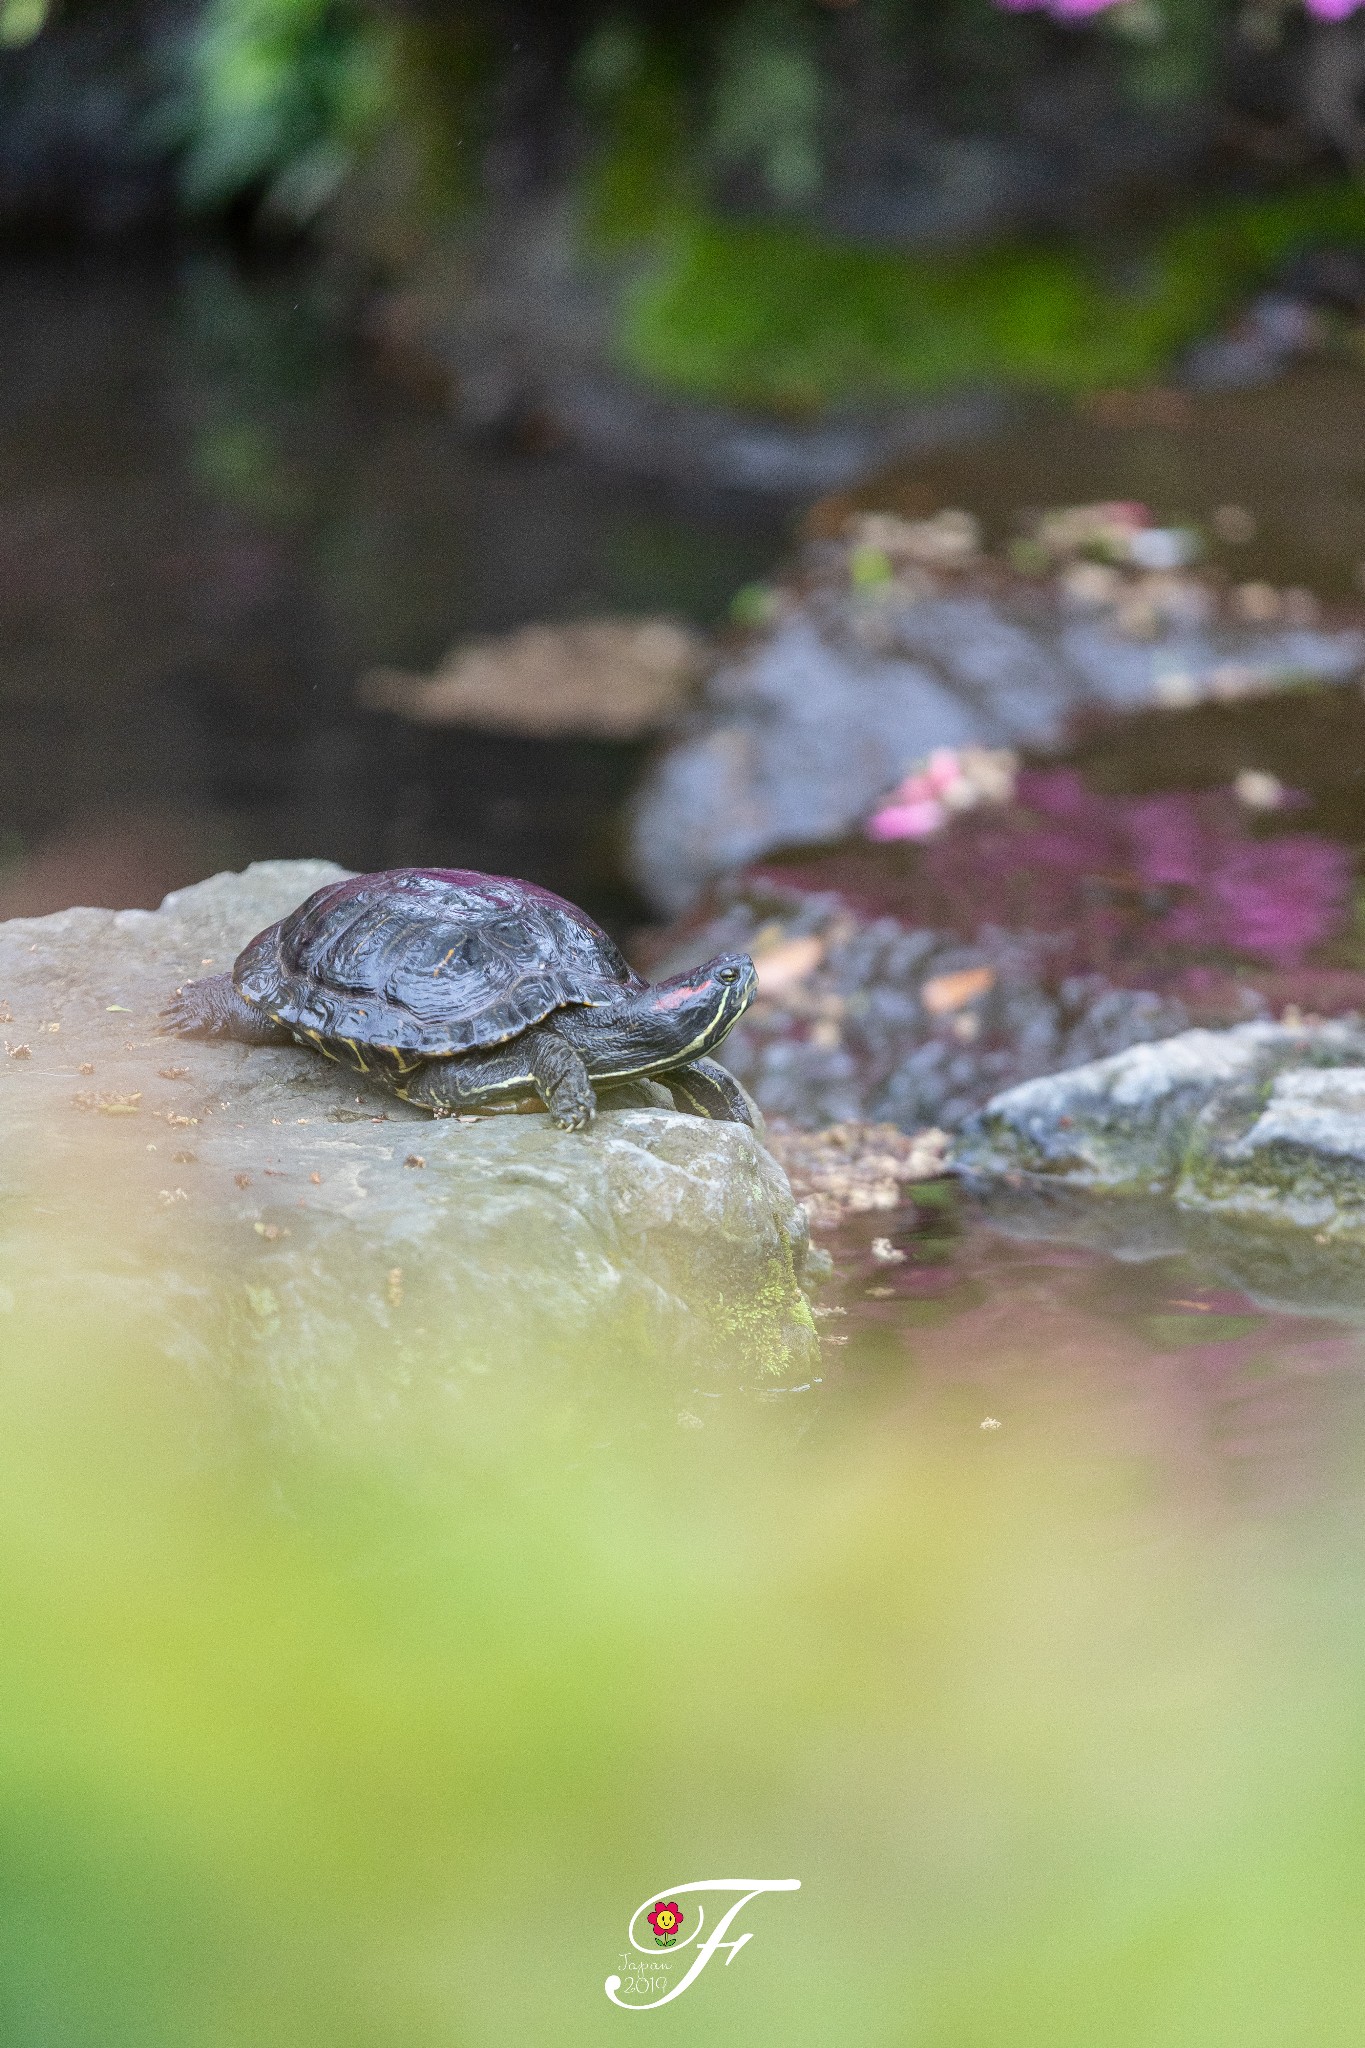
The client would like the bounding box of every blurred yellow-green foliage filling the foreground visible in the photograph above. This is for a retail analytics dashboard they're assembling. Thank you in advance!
[0,1253,1365,2048]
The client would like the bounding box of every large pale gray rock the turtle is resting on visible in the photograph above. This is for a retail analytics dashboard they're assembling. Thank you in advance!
[0,862,817,1415]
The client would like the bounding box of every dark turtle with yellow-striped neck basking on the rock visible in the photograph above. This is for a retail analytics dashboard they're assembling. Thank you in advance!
[162,868,757,1130]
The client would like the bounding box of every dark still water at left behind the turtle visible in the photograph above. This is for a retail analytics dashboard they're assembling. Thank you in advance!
[0,254,786,922]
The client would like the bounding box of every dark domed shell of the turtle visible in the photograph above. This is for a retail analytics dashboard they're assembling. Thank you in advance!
[233,868,645,1061]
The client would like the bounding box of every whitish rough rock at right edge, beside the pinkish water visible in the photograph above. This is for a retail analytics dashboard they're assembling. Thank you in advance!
[956,1020,1365,1247]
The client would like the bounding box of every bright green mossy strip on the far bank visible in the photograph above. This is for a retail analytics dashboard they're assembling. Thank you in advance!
[622,182,1365,412]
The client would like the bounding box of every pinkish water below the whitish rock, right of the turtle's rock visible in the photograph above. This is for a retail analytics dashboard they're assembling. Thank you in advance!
[817,1188,1365,1511]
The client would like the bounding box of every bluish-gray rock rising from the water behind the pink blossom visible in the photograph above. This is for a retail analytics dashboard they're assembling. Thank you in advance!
[630,586,1365,915]
